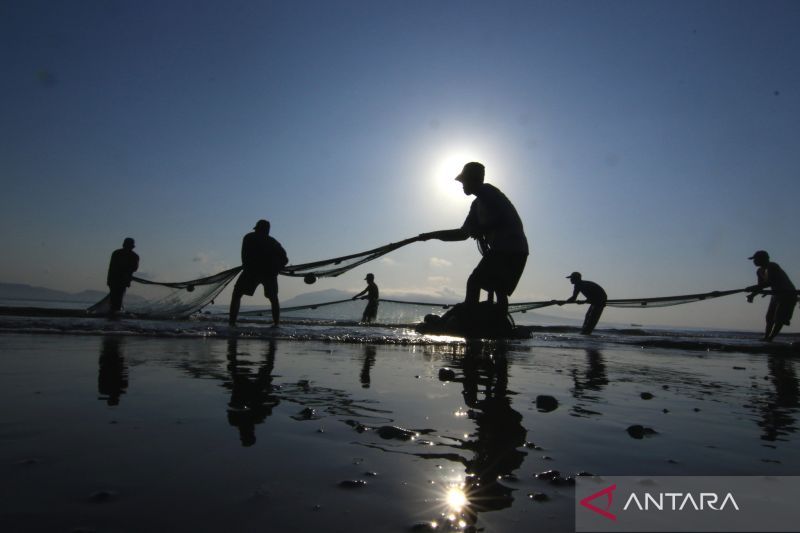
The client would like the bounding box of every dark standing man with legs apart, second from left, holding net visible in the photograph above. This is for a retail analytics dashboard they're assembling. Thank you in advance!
[228,220,289,326]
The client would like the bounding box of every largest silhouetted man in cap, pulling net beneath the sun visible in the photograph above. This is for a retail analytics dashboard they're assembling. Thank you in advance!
[419,162,528,314]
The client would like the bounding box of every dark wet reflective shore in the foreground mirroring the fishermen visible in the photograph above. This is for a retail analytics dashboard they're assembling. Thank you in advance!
[0,326,800,532]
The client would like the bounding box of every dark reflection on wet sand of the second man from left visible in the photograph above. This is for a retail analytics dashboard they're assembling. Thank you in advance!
[224,338,280,446]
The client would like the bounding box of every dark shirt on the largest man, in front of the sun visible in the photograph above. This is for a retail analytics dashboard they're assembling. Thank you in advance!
[461,183,528,254]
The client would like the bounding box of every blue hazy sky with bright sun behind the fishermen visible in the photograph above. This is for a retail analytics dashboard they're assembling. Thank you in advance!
[0,0,800,331]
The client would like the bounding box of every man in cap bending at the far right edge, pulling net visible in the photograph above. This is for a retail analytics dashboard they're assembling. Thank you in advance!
[747,250,797,342]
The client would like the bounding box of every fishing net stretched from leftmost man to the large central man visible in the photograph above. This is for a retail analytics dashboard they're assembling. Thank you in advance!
[87,237,419,318]
